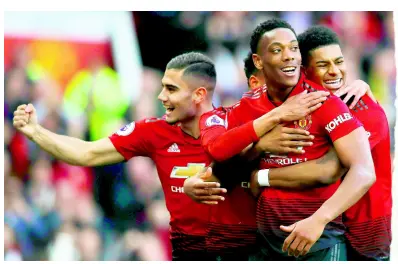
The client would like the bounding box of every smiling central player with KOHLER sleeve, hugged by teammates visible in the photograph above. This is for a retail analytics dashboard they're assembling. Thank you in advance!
[201,20,375,260]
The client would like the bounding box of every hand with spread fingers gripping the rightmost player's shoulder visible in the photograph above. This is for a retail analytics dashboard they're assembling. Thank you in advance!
[334,80,376,109]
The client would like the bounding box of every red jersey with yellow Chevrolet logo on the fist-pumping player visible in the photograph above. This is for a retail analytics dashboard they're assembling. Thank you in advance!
[109,118,210,254]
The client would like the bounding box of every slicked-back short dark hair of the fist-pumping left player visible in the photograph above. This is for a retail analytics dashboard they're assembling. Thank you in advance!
[166,52,217,88]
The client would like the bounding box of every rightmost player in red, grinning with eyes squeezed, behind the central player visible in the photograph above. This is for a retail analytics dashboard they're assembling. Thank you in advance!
[298,26,392,260]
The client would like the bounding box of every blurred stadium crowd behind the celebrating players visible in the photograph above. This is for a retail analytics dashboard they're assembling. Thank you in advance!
[4,12,396,260]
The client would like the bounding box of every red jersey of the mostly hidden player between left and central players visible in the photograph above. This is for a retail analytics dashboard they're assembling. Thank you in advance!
[200,107,257,253]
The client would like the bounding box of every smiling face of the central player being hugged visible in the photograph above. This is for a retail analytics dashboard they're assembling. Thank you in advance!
[253,28,301,89]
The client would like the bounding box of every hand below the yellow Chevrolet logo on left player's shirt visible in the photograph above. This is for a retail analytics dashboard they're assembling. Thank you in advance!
[184,167,227,204]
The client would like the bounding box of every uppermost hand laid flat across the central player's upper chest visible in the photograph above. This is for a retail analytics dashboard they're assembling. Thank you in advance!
[276,91,330,122]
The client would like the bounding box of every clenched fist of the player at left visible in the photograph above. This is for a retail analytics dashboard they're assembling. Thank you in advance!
[13,104,38,138]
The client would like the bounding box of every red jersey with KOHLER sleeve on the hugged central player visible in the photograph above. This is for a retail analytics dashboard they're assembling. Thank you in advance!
[222,74,361,254]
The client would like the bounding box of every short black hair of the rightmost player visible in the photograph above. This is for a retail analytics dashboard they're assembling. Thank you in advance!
[297,26,340,66]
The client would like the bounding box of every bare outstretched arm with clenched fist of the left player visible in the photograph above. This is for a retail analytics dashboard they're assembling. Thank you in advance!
[13,104,124,166]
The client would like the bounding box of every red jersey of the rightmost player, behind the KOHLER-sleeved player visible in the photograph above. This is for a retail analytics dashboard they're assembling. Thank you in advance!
[343,95,392,259]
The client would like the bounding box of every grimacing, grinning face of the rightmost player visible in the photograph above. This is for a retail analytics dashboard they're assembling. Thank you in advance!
[306,44,346,93]
